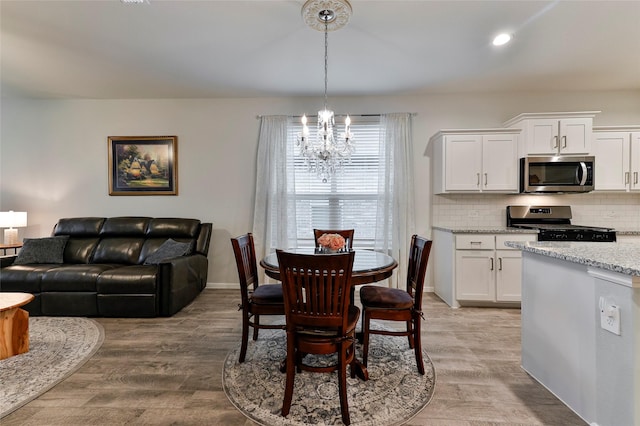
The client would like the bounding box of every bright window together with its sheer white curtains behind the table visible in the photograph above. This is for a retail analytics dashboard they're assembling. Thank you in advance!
[253,113,414,287]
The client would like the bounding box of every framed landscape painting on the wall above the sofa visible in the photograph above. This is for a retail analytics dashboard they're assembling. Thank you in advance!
[108,136,178,195]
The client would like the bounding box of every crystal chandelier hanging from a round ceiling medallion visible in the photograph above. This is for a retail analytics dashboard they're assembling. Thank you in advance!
[297,0,354,182]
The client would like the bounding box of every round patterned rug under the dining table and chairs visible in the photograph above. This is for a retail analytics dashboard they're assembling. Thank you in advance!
[222,324,436,426]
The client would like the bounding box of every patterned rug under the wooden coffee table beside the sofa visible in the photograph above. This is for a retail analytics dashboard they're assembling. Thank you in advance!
[0,317,104,418]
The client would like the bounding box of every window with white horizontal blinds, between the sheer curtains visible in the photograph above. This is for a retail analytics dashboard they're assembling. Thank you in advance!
[287,116,381,248]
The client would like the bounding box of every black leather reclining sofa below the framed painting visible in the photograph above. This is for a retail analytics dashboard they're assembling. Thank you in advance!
[0,217,212,317]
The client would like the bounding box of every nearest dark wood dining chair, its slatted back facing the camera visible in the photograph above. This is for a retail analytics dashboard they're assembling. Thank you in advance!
[276,250,360,425]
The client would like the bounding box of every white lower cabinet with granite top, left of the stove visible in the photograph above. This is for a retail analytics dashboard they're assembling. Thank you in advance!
[433,230,537,307]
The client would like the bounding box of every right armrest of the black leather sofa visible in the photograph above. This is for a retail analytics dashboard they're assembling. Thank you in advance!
[158,253,209,316]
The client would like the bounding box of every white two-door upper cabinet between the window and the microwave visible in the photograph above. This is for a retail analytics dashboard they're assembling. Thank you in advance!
[431,129,520,194]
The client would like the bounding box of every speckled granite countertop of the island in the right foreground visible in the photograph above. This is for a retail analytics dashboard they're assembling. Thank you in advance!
[505,241,640,276]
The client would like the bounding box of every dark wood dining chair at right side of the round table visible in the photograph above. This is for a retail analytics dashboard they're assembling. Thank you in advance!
[360,235,432,375]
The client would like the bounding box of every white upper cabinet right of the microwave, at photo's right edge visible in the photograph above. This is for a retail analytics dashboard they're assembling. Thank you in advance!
[593,126,640,191]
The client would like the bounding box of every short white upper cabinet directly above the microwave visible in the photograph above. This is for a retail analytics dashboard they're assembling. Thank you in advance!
[504,111,600,157]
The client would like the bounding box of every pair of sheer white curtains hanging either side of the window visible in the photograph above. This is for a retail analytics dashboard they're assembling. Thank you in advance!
[253,113,414,287]
